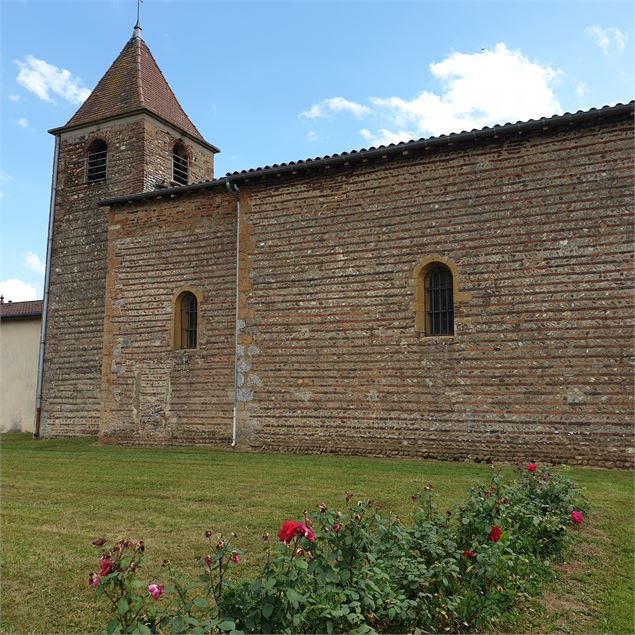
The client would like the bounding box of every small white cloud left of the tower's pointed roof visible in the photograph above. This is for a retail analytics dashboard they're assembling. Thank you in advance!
[16,55,90,104]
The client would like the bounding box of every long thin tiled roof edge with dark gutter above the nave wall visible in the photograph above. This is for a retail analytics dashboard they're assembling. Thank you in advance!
[98,101,635,206]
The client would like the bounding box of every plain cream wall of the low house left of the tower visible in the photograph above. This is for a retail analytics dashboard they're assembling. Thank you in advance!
[0,317,41,432]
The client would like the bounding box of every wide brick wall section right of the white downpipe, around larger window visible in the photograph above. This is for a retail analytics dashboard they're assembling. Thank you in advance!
[235,120,634,466]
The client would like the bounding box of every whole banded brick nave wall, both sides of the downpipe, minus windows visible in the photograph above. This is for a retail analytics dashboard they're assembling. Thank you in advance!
[85,112,634,466]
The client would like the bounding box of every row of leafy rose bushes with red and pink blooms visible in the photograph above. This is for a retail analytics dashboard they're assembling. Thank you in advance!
[89,464,587,633]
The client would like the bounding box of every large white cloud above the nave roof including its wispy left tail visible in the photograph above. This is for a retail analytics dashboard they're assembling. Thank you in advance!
[300,42,568,145]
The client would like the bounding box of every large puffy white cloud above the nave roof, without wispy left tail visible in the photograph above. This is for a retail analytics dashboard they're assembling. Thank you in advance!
[371,43,562,136]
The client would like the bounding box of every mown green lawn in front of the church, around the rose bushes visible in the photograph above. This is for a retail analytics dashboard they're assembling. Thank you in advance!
[0,434,635,633]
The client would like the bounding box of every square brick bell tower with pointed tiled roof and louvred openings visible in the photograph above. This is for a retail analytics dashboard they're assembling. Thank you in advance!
[36,24,219,437]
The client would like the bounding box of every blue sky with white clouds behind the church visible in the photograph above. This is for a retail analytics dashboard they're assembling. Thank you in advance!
[0,0,635,301]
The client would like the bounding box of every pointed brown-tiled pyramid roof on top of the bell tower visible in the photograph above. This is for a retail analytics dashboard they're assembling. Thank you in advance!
[62,29,205,141]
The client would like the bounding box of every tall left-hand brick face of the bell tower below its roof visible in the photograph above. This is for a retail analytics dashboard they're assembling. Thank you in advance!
[41,121,148,436]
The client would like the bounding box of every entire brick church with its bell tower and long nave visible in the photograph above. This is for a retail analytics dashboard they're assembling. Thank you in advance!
[37,26,635,467]
